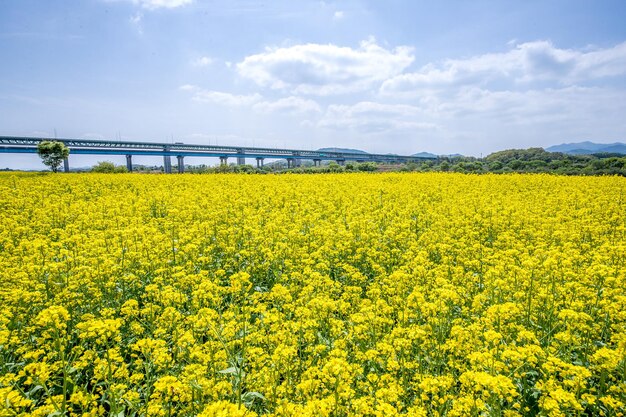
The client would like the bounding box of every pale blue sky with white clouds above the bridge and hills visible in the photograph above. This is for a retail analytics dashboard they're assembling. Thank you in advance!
[0,0,626,168]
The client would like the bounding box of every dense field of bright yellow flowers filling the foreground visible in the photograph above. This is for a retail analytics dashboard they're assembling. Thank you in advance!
[0,173,626,417]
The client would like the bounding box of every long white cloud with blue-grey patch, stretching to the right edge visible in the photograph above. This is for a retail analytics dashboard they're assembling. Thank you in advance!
[381,41,626,94]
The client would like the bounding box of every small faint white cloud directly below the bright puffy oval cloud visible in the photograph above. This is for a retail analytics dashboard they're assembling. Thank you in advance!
[318,101,437,133]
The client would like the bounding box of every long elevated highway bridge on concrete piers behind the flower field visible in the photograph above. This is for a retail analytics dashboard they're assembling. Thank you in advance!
[0,136,431,173]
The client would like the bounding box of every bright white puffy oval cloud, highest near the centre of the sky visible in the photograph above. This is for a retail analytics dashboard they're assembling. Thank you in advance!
[237,39,414,95]
